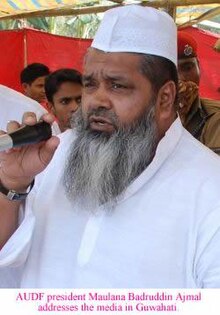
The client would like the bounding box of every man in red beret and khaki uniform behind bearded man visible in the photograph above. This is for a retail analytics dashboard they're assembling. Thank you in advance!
[178,31,220,154]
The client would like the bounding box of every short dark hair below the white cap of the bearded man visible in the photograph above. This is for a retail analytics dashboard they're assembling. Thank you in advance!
[140,54,178,106]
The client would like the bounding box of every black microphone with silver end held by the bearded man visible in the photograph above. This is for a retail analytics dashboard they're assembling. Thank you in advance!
[0,121,52,151]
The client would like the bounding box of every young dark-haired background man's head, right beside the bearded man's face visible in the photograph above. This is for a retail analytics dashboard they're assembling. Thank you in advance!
[45,69,82,132]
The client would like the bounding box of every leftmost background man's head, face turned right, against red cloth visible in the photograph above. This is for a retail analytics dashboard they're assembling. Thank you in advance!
[20,63,50,105]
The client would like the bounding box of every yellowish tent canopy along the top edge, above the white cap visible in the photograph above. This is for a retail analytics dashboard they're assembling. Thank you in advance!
[0,0,220,24]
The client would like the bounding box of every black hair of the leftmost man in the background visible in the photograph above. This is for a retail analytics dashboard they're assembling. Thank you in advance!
[20,63,50,84]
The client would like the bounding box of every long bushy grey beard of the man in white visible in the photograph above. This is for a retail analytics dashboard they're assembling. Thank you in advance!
[63,104,158,212]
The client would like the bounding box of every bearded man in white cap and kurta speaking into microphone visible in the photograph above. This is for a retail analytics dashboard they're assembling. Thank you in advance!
[0,5,220,288]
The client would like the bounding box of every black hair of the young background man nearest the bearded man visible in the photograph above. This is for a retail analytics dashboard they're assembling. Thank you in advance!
[45,68,82,103]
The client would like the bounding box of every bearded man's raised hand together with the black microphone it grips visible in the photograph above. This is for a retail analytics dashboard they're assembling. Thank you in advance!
[0,113,59,191]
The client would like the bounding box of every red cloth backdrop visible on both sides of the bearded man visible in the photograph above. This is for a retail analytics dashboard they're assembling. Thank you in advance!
[0,27,220,100]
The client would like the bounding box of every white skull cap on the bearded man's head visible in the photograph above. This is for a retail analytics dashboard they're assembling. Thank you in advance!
[91,5,177,65]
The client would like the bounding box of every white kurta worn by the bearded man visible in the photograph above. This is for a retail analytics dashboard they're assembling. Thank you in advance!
[0,119,220,288]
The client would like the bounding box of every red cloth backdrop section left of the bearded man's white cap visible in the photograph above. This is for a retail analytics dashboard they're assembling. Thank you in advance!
[0,29,91,91]
